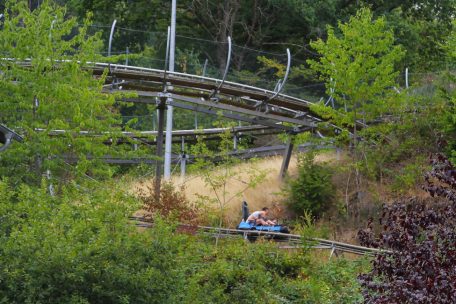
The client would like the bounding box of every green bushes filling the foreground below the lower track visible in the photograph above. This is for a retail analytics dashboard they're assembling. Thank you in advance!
[0,177,363,303]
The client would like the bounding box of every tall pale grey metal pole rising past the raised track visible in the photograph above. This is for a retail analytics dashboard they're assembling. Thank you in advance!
[164,0,177,179]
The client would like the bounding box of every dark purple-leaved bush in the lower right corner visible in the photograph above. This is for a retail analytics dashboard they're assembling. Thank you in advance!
[359,155,456,303]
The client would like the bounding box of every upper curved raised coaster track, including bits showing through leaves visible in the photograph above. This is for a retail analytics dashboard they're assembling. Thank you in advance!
[0,58,365,133]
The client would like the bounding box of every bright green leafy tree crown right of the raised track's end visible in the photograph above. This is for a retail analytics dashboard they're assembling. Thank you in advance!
[308,8,404,125]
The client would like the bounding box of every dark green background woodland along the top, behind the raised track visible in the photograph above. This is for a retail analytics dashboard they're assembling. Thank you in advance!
[40,0,455,78]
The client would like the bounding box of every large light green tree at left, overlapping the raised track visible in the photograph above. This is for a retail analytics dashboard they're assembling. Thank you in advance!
[0,1,123,182]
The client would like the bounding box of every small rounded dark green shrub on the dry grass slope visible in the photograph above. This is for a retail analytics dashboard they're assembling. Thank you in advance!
[286,152,334,217]
